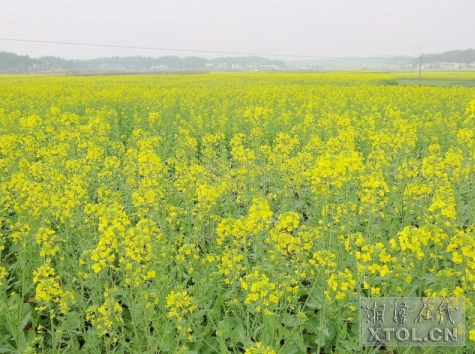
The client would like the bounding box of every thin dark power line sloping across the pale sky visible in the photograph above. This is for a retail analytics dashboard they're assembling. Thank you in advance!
[0,38,409,60]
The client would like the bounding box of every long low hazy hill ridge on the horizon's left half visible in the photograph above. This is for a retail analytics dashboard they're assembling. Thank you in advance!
[0,52,285,72]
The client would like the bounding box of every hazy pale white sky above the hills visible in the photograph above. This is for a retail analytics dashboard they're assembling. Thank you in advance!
[0,0,475,59]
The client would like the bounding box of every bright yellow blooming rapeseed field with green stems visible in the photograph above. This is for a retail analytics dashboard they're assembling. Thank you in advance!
[0,72,475,354]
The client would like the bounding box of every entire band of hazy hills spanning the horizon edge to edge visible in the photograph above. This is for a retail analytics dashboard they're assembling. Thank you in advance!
[0,49,475,73]
